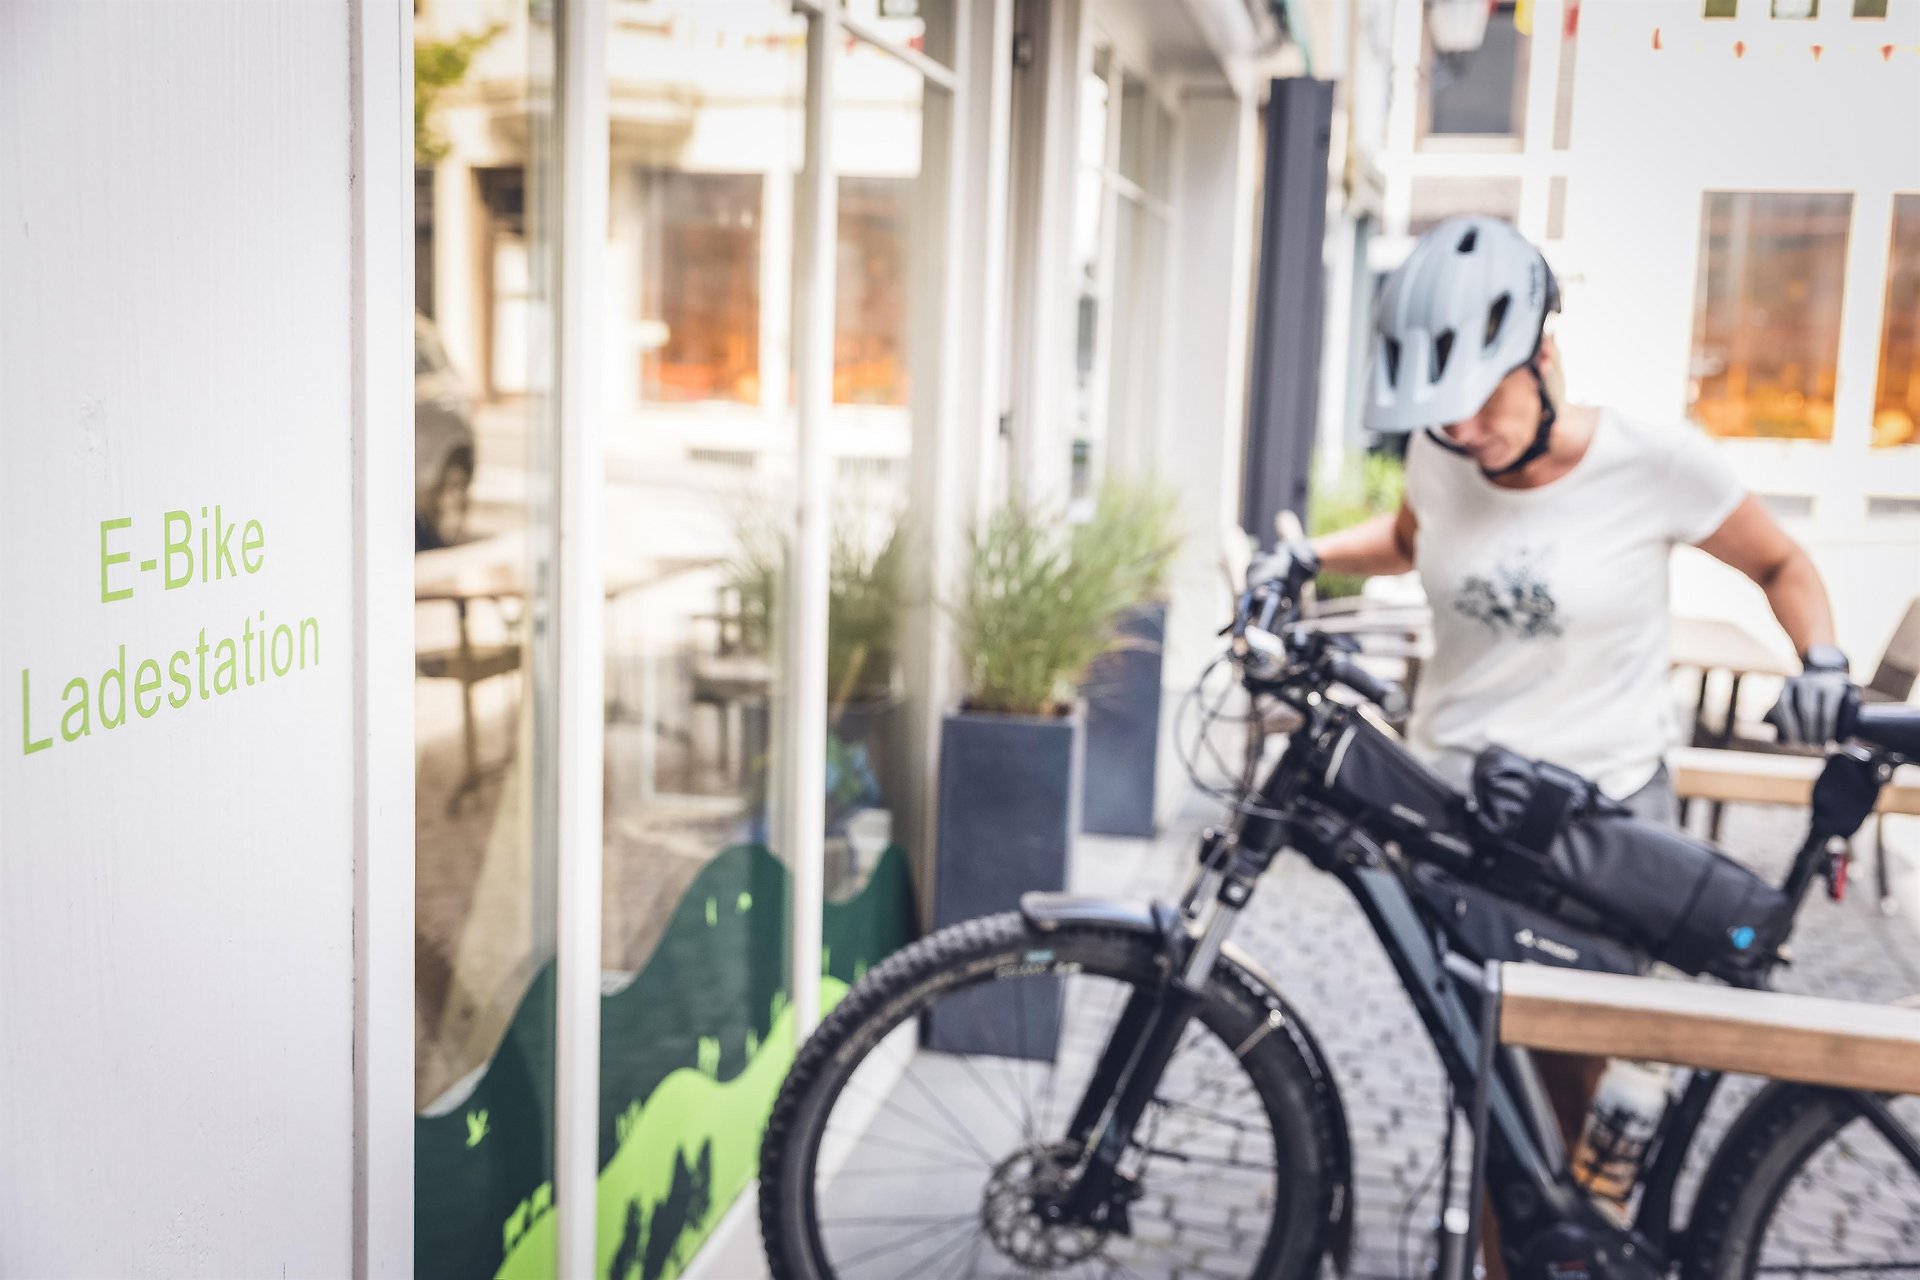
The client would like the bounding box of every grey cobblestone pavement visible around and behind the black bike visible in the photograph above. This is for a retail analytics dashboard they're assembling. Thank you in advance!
[1113,804,1920,1280]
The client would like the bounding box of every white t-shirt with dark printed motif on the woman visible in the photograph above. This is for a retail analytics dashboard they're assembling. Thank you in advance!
[1405,409,1745,798]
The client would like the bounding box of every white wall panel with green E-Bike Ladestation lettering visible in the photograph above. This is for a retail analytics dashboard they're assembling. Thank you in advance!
[0,0,360,1276]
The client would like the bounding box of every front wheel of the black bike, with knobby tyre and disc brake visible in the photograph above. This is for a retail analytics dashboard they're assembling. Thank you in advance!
[760,913,1336,1280]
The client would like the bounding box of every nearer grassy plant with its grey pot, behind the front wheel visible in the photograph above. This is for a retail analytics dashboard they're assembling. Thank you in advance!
[925,503,1127,1057]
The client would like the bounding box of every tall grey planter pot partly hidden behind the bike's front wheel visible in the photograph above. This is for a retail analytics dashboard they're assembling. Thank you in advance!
[922,712,1085,1061]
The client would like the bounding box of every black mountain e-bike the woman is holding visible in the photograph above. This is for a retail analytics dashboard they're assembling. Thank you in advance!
[760,591,1920,1280]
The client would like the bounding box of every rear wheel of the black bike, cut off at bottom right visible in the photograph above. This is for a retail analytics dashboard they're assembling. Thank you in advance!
[1684,1084,1920,1280]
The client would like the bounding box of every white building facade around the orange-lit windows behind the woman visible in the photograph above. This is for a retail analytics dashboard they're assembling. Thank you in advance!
[1559,0,1920,674]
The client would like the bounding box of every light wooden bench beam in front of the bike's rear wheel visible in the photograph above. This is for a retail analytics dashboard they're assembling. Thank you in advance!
[1500,965,1920,1094]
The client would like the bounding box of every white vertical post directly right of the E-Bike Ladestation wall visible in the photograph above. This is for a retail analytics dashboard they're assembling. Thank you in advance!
[348,0,415,1280]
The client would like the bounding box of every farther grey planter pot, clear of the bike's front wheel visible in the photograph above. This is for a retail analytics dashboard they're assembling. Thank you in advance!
[1081,604,1167,837]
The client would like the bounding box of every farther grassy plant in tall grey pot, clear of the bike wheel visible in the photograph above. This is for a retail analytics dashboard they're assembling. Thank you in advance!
[1079,480,1179,837]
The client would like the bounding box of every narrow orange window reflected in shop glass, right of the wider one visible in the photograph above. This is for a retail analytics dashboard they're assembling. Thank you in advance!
[833,177,912,405]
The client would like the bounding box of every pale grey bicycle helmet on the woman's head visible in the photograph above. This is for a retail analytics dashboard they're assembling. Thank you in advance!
[1367,215,1559,470]
